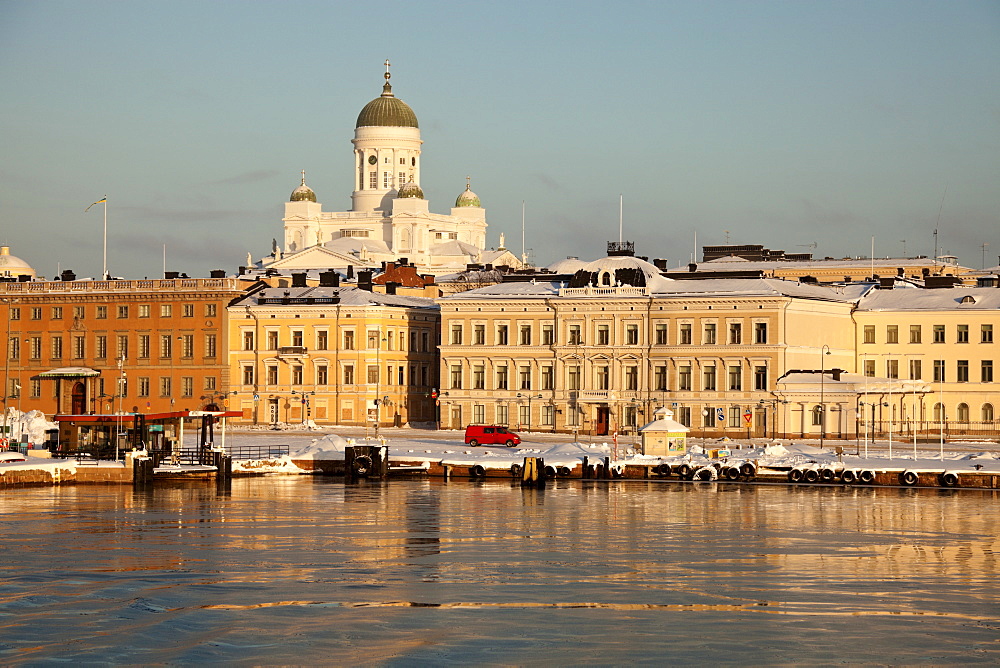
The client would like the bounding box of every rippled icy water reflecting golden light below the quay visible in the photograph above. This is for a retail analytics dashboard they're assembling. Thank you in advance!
[0,477,1000,665]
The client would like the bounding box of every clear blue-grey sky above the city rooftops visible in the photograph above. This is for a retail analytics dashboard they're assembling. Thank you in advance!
[0,0,1000,278]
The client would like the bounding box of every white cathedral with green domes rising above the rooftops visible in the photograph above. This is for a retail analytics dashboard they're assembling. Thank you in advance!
[251,61,521,274]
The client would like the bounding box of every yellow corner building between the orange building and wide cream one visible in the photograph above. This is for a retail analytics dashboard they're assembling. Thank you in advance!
[234,280,439,426]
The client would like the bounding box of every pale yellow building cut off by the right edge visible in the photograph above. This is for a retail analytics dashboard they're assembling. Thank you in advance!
[854,286,1000,437]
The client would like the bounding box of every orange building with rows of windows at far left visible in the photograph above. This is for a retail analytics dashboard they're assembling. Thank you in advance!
[0,276,245,416]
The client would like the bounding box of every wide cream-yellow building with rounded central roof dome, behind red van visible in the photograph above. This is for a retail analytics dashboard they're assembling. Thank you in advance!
[438,256,862,437]
